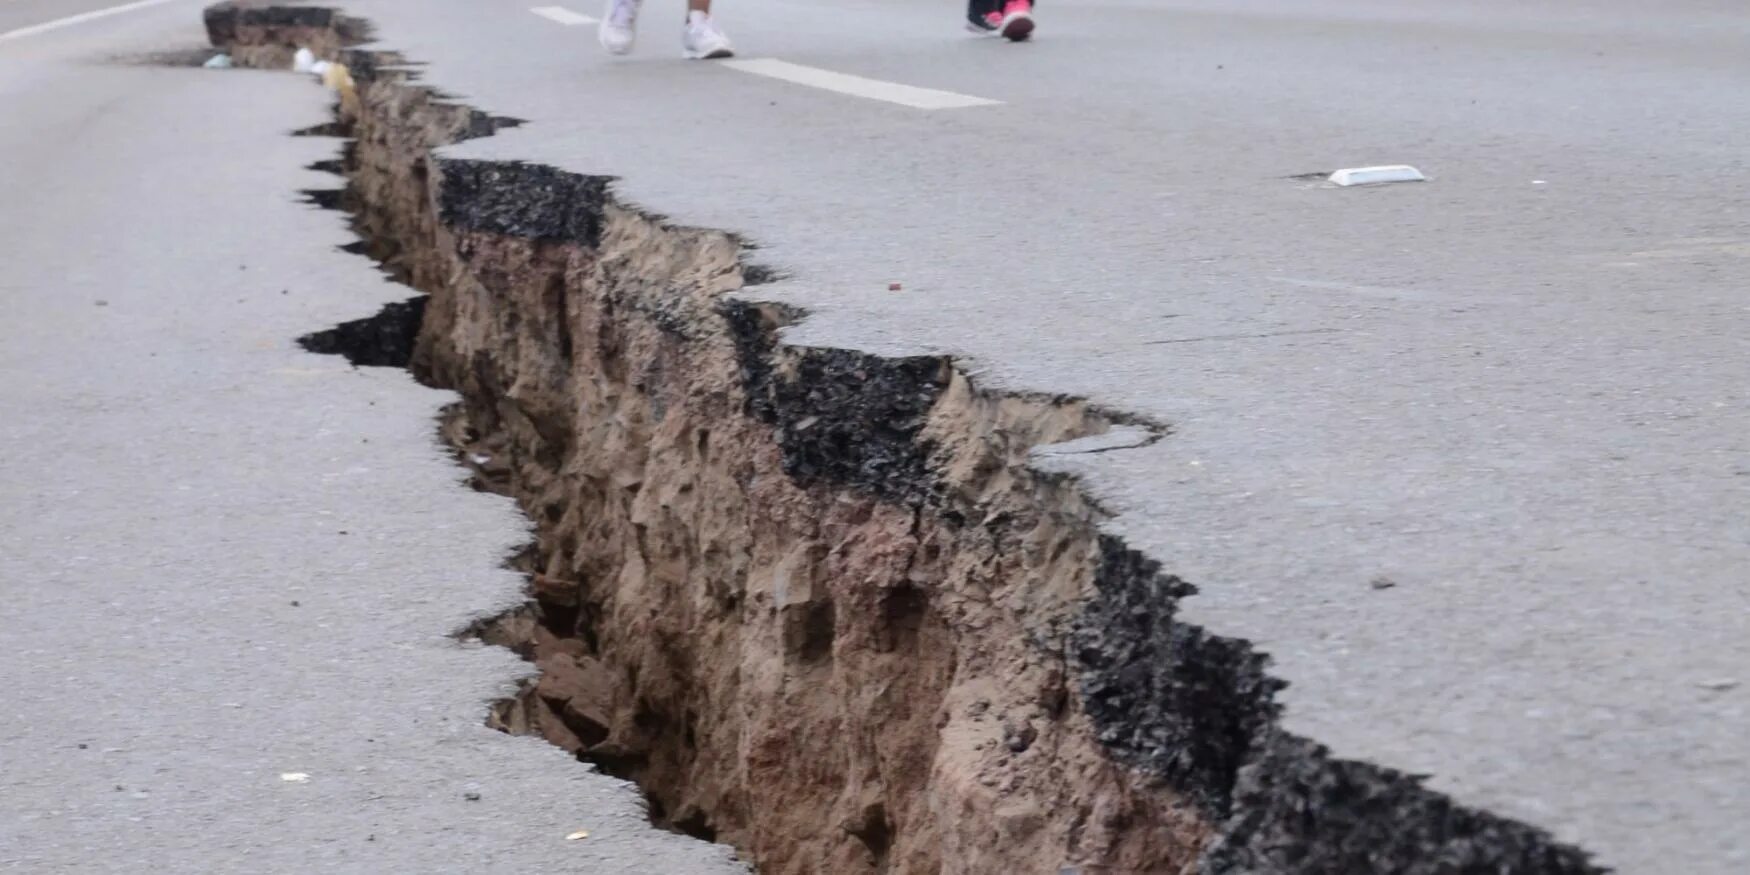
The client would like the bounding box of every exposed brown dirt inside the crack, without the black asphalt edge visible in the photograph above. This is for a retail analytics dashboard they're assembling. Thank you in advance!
[218,15,1208,873]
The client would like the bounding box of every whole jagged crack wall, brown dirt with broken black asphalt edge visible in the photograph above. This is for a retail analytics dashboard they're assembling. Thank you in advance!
[208,5,1594,873]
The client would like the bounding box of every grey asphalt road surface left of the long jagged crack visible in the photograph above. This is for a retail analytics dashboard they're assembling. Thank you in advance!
[0,5,740,875]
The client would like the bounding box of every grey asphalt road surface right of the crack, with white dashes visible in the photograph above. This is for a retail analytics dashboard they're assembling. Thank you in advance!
[0,0,1750,875]
